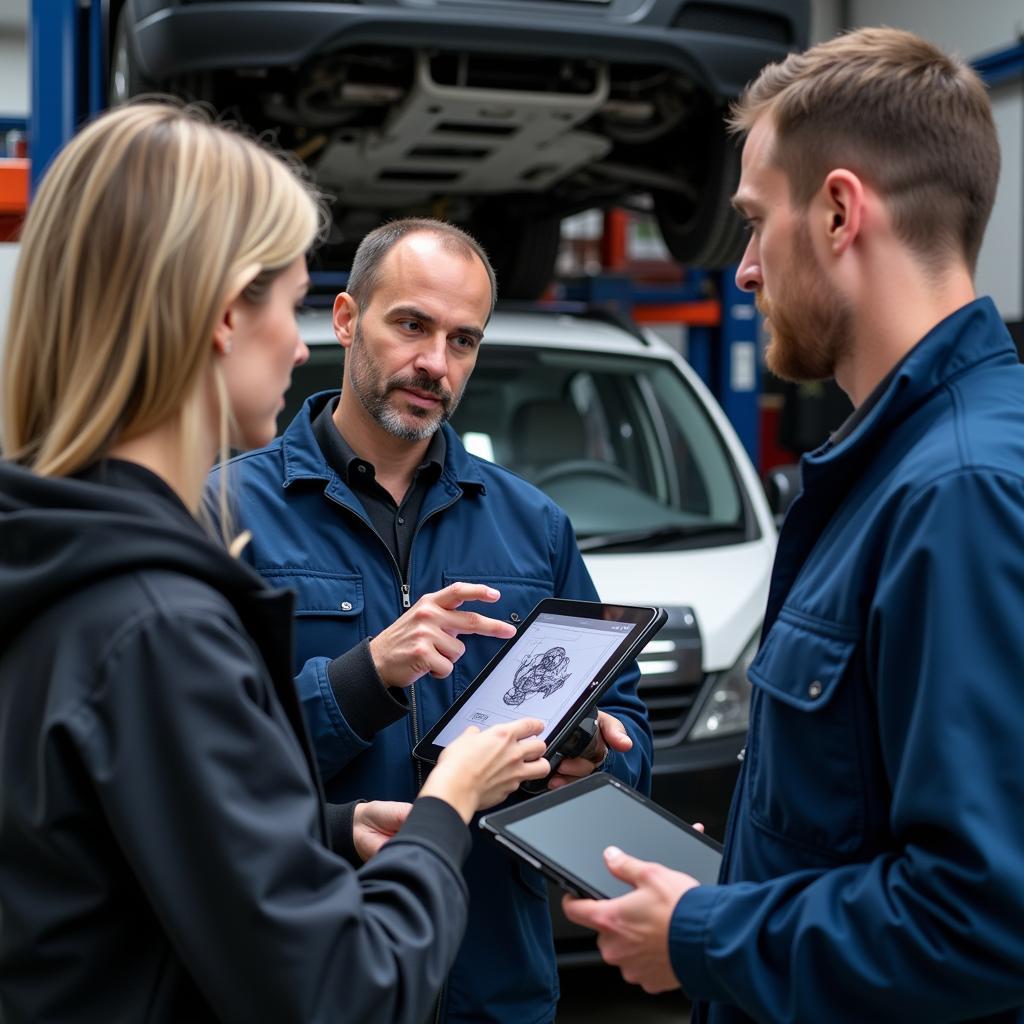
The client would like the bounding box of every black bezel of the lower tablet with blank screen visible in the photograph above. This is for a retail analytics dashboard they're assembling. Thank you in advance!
[479,772,723,899]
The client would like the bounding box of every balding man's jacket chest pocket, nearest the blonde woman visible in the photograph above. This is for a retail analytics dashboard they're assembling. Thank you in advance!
[260,569,366,668]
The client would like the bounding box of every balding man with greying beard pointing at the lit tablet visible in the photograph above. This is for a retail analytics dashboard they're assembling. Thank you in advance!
[211,219,651,1024]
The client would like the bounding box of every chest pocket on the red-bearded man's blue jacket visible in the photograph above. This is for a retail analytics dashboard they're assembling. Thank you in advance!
[746,609,866,859]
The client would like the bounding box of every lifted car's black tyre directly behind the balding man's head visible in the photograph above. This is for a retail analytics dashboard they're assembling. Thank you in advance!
[472,207,562,299]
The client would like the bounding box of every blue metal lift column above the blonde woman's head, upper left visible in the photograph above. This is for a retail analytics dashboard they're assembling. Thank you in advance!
[29,0,79,190]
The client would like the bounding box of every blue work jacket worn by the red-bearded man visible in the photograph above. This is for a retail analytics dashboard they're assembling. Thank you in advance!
[670,299,1024,1024]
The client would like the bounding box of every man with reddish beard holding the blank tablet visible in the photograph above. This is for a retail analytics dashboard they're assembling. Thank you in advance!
[566,29,1024,1024]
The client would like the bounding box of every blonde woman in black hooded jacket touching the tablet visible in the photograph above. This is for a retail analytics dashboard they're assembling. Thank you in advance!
[0,104,548,1024]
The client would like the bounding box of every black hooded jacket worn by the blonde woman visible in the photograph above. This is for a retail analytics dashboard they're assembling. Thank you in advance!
[0,460,469,1024]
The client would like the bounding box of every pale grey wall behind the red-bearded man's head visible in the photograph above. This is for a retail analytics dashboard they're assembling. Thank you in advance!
[849,0,1024,324]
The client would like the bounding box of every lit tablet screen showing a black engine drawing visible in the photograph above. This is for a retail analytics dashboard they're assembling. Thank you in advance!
[434,612,637,746]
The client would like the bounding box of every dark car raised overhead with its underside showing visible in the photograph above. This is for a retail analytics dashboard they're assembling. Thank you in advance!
[108,0,809,298]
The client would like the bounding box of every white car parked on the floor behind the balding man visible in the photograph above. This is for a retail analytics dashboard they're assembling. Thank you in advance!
[279,306,776,962]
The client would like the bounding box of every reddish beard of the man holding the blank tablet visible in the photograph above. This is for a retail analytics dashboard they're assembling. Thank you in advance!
[756,222,853,381]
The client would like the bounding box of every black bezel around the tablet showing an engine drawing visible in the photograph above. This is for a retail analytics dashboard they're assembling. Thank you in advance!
[413,597,667,765]
